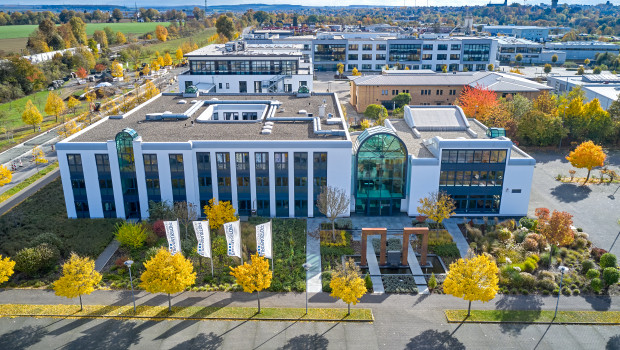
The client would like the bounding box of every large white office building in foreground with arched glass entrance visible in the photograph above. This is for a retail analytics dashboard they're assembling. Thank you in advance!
[57,94,535,219]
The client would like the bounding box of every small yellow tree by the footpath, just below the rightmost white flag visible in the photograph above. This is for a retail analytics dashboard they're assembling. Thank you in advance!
[230,253,272,314]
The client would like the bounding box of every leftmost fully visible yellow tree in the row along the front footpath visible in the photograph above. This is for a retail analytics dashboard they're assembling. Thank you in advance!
[54,253,101,311]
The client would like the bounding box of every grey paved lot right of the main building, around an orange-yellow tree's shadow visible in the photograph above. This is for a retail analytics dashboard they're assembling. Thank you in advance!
[528,151,620,255]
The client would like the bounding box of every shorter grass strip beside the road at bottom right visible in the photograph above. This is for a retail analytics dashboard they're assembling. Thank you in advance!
[445,310,620,325]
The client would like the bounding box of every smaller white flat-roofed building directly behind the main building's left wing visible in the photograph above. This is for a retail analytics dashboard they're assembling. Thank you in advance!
[178,41,313,94]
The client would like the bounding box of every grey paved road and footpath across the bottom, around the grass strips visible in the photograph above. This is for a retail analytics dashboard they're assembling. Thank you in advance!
[0,290,620,350]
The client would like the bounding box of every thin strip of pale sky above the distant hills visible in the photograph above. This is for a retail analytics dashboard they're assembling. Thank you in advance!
[0,0,620,8]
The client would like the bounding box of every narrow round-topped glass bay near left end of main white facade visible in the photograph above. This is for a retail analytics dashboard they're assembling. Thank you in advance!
[114,128,140,219]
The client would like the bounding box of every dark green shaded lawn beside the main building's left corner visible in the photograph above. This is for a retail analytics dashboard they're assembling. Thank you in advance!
[0,178,119,258]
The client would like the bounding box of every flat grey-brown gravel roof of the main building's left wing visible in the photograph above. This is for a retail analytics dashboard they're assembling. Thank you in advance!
[67,94,347,142]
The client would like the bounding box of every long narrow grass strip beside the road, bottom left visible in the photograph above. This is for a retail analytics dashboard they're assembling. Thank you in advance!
[0,304,374,322]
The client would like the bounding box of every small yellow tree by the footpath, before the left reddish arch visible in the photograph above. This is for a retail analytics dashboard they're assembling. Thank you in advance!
[329,258,367,315]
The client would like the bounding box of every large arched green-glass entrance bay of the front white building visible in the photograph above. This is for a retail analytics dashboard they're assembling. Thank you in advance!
[355,127,408,216]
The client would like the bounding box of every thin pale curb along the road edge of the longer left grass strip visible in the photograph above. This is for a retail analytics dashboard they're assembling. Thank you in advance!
[0,314,375,323]
